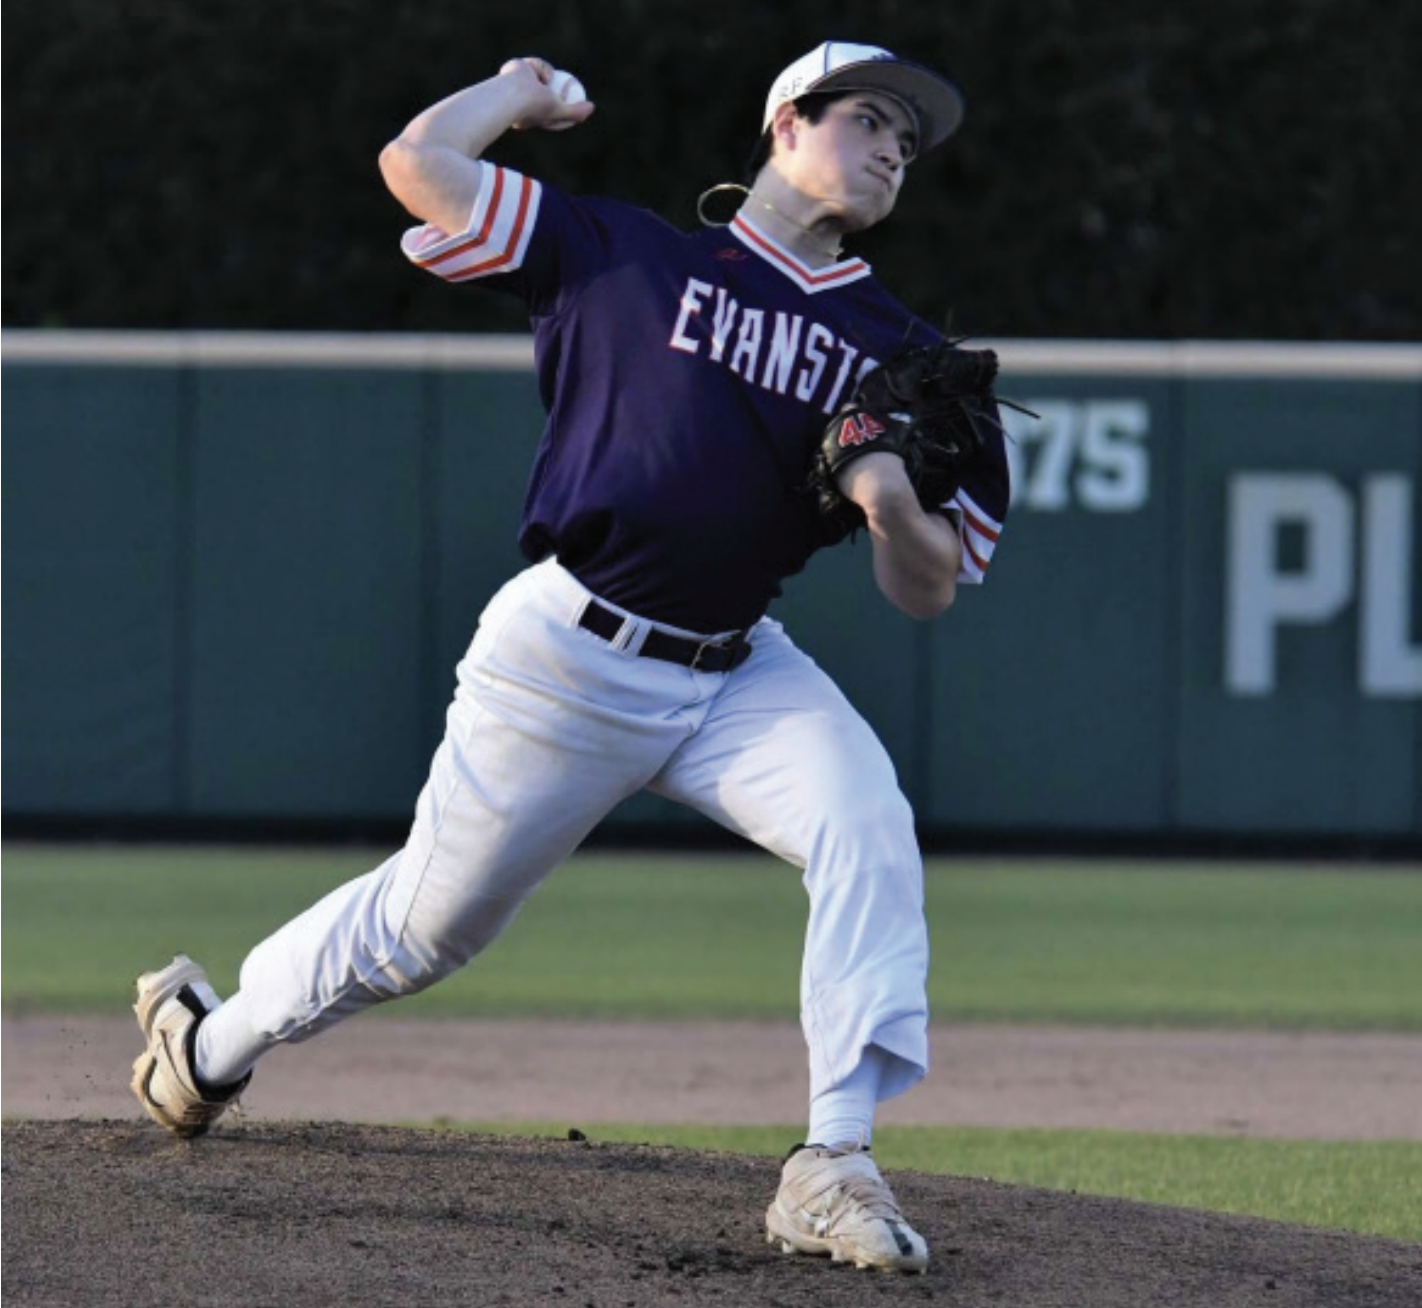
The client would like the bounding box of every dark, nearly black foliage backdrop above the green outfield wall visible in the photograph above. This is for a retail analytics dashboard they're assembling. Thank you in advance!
[3,0,1422,341]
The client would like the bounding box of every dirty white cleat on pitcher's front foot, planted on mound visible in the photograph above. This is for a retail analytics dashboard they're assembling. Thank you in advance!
[765,1145,929,1272]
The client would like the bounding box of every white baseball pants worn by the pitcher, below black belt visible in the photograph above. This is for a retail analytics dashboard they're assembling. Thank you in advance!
[233,560,929,1099]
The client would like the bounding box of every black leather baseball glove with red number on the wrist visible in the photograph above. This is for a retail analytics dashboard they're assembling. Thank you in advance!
[809,341,1003,530]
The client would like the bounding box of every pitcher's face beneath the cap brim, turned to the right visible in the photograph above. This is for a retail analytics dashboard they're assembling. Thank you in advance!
[795,91,919,232]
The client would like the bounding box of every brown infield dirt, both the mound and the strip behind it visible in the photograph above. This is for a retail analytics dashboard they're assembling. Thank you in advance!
[3,1017,1422,1308]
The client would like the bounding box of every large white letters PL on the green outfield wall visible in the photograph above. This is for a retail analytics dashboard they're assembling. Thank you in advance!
[1224,472,1422,698]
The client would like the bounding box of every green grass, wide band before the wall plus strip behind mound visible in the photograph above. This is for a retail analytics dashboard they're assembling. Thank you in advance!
[3,845,1422,1240]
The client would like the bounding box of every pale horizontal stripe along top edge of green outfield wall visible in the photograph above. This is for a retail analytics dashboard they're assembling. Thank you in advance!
[0,328,1422,381]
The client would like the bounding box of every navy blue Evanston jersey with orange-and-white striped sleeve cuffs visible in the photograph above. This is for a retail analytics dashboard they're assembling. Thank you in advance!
[404,164,1008,633]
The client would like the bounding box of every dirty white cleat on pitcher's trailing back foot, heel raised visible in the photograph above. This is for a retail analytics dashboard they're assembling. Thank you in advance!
[132,954,252,1139]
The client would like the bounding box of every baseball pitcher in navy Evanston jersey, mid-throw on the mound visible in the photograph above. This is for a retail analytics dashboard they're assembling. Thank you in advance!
[134,41,1008,1271]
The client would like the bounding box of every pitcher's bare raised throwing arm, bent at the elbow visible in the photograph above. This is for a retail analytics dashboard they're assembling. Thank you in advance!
[380,58,593,232]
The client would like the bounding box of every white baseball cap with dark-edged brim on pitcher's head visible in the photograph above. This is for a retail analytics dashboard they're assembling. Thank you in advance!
[761,41,963,154]
